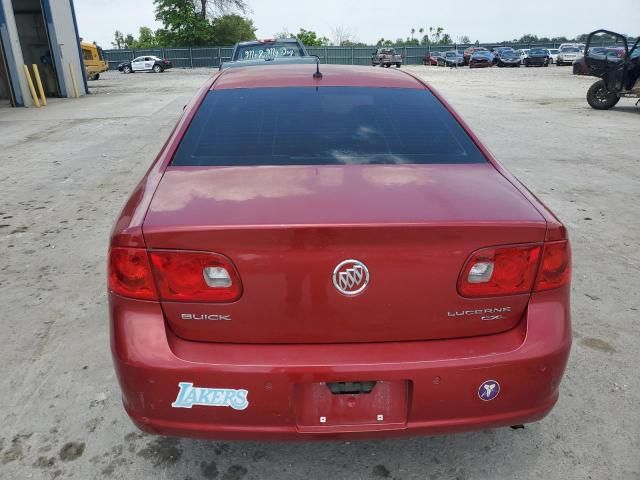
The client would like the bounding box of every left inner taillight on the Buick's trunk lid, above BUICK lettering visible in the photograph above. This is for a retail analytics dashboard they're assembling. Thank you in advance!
[149,251,242,302]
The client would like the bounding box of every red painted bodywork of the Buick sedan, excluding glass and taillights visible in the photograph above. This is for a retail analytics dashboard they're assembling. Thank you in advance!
[109,65,571,439]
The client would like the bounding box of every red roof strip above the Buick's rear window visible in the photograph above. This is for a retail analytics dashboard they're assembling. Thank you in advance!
[211,65,427,90]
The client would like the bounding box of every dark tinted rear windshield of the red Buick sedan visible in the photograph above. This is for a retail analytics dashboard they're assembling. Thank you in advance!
[172,87,486,166]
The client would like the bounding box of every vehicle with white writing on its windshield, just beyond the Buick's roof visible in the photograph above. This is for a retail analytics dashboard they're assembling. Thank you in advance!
[220,38,317,70]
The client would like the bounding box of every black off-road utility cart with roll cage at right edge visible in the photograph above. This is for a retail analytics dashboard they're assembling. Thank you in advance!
[584,30,640,110]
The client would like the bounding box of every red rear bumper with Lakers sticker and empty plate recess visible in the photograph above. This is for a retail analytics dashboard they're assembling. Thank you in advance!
[110,290,571,439]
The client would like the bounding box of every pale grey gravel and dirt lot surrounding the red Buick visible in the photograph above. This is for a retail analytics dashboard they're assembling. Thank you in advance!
[0,67,640,480]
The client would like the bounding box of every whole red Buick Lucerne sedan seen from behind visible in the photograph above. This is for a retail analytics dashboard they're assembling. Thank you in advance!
[108,65,571,439]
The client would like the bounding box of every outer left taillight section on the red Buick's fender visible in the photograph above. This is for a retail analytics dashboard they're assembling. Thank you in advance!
[108,247,158,300]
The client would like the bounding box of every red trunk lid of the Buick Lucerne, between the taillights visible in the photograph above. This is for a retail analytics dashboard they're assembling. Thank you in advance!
[144,164,546,343]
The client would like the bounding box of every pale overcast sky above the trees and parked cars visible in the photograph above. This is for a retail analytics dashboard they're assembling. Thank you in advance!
[74,0,640,48]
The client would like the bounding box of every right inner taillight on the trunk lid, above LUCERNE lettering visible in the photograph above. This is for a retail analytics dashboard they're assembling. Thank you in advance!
[458,245,542,297]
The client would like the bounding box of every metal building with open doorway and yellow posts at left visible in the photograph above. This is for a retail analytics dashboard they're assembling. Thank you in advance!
[0,0,88,107]
